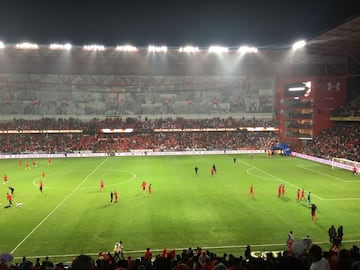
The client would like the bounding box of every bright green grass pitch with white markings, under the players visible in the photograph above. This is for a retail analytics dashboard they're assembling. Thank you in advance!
[0,155,360,261]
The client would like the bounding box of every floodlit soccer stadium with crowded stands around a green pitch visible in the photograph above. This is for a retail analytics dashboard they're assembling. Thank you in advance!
[0,17,360,270]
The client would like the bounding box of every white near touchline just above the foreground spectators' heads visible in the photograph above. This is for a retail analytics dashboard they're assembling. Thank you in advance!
[14,239,360,259]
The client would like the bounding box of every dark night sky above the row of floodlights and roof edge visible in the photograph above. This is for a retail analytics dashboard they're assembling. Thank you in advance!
[0,0,360,48]
